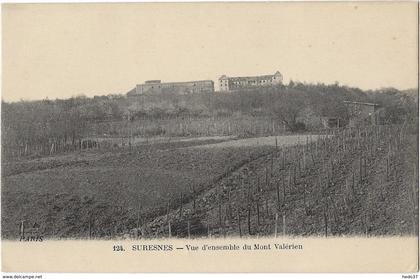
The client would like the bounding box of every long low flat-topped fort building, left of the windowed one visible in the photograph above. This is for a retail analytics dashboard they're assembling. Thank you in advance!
[128,80,214,95]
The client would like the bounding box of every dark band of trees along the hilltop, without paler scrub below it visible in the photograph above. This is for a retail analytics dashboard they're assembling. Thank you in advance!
[2,81,418,157]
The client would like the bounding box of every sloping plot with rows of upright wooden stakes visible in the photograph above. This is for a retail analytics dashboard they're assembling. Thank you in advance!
[144,126,418,240]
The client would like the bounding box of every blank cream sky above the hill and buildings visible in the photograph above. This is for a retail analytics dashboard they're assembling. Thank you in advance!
[2,1,418,101]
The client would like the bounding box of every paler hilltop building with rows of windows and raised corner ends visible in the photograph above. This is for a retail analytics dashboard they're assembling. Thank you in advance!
[219,71,283,91]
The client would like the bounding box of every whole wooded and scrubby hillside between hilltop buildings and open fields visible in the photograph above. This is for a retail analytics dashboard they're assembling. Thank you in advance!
[2,83,417,158]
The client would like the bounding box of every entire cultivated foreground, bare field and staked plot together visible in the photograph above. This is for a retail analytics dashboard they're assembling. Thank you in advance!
[2,126,418,241]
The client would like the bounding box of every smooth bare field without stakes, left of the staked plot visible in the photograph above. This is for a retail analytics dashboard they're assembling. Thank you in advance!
[2,137,316,238]
